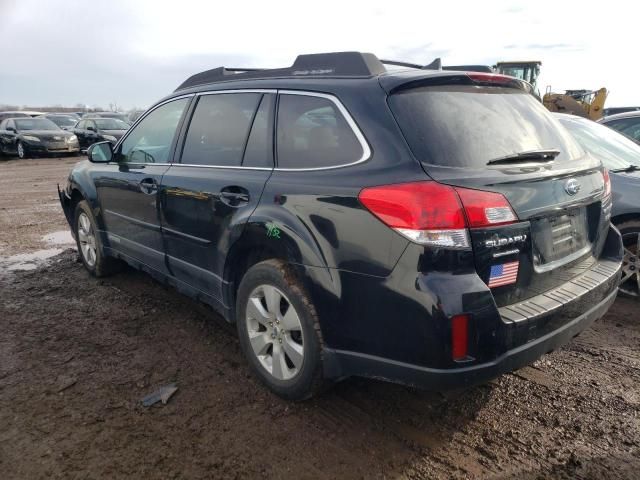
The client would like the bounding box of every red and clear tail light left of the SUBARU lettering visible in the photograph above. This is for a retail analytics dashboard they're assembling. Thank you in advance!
[358,181,517,249]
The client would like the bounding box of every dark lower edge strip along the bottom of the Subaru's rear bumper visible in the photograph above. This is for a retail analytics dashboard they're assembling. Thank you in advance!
[326,289,617,391]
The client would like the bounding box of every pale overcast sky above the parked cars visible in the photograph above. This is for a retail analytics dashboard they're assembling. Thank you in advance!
[0,0,640,109]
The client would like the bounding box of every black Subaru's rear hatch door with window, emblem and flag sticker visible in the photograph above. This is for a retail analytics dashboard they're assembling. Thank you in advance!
[383,74,609,306]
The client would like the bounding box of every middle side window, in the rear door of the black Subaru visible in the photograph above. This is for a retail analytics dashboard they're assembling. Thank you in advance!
[182,93,262,167]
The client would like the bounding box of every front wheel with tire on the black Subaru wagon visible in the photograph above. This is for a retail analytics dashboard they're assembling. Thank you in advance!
[73,200,119,277]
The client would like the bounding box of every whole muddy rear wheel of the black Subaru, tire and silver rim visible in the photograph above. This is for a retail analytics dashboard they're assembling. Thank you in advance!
[236,259,325,401]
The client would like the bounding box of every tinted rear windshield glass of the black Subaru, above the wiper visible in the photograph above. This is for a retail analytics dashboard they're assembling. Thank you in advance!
[389,86,583,168]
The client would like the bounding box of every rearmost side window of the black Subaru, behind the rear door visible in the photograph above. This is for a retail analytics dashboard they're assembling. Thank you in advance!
[277,94,364,169]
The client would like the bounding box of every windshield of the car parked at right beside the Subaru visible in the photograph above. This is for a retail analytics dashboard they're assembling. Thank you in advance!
[559,117,640,170]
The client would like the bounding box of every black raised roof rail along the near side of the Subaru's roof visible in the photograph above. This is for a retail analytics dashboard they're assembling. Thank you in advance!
[176,52,386,91]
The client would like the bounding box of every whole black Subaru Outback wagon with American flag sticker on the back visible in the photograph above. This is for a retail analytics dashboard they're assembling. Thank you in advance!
[60,52,622,399]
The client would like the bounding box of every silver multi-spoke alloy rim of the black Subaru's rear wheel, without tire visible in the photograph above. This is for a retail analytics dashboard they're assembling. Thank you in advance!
[245,285,304,380]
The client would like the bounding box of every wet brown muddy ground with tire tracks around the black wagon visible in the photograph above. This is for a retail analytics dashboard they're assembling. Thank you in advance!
[0,159,640,480]
